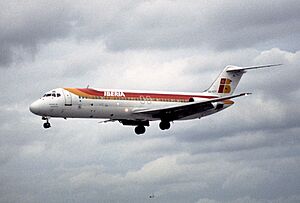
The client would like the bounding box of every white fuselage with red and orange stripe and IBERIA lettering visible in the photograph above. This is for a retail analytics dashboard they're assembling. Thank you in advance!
[30,88,231,121]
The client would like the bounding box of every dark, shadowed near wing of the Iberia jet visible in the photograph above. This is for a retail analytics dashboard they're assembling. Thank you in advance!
[134,93,251,121]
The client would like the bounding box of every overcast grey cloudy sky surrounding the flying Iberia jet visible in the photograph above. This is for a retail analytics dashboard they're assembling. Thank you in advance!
[0,0,300,203]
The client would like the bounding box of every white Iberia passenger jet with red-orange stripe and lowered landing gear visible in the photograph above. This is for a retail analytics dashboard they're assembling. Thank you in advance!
[29,64,282,135]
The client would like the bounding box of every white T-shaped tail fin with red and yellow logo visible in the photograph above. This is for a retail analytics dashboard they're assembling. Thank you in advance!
[205,64,282,96]
